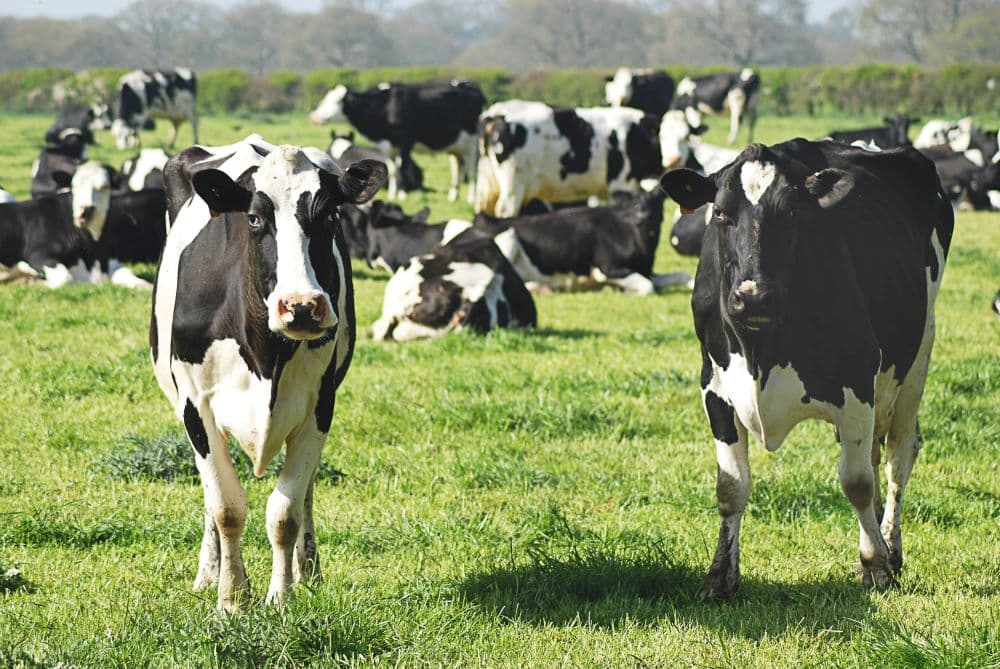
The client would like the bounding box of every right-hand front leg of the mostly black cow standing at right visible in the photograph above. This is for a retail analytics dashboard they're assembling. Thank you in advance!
[837,397,893,590]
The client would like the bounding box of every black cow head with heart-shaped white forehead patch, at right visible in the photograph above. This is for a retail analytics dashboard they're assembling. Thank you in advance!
[660,144,854,334]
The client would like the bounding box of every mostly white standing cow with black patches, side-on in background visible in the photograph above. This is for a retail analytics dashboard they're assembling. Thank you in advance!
[475,100,662,217]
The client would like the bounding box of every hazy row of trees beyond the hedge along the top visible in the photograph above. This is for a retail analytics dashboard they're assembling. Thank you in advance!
[0,0,1000,76]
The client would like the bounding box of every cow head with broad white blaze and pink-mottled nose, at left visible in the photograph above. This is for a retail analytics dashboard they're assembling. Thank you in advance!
[192,146,386,339]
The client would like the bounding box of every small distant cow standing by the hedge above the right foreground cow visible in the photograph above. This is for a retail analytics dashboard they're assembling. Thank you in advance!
[673,68,760,144]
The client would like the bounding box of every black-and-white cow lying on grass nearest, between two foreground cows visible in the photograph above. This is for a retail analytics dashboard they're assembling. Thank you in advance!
[371,230,538,341]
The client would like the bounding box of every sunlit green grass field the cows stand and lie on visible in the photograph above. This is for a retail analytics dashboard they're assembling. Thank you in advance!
[0,116,1000,668]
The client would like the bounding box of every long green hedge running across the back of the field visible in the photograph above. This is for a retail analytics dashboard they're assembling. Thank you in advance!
[0,64,1000,116]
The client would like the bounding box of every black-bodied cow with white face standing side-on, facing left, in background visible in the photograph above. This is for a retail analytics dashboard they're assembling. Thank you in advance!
[309,80,486,201]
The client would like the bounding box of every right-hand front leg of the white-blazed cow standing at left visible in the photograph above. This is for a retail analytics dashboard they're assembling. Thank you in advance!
[267,428,326,604]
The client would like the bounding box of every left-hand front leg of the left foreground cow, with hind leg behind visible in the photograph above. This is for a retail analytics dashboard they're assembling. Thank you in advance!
[184,408,250,611]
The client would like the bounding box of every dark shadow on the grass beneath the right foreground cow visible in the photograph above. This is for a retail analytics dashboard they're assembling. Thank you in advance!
[458,556,873,640]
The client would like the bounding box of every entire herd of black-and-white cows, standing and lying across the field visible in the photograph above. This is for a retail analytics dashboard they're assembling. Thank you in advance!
[0,65,1000,609]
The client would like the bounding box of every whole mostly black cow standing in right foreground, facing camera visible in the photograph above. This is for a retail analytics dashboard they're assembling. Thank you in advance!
[662,139,954,599]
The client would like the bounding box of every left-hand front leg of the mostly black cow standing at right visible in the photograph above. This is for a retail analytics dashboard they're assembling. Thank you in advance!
[698,390,750,601]
